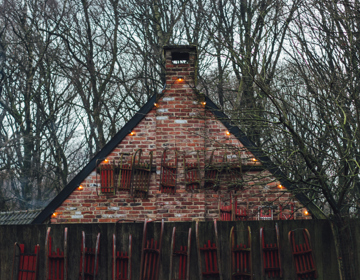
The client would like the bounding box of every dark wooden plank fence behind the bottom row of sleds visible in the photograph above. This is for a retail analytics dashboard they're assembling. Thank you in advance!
[0,220,350,280]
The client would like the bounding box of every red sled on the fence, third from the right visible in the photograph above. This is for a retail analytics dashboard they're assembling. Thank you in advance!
[230,226,252,280]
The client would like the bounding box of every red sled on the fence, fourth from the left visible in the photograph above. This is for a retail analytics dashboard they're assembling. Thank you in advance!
[112,234,132,280]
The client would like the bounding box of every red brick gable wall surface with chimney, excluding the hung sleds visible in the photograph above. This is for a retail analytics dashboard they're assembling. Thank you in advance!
[51,49,308,223]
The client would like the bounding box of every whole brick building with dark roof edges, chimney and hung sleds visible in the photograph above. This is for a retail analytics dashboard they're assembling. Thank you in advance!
[33,46,316,223]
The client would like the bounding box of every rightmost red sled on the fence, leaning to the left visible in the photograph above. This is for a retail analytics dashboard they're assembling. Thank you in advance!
[289,228,317,280]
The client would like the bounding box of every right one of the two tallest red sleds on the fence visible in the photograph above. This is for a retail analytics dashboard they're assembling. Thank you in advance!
[196,220,223,280]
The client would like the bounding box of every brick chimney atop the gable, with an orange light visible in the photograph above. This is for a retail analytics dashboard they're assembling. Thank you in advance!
[164,45,197,88]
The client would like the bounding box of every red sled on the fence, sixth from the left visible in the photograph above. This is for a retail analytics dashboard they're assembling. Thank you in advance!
[169,227,191,280]
